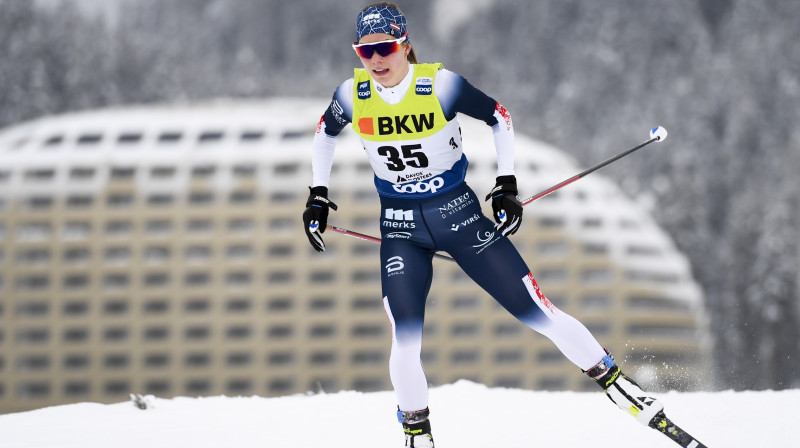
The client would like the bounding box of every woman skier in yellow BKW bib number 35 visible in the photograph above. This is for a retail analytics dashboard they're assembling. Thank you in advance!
[303,2,663,448]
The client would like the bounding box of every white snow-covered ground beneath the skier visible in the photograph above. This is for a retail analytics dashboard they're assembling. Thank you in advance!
[0,381,800,448]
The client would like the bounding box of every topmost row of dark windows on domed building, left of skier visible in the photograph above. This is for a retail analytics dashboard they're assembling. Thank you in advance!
[11,129,311,149]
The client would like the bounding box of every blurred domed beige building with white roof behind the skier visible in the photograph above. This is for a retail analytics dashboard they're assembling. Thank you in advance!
[0,100,707,412]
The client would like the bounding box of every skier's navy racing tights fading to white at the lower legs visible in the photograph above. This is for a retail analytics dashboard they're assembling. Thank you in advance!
[380,184,606,411]
